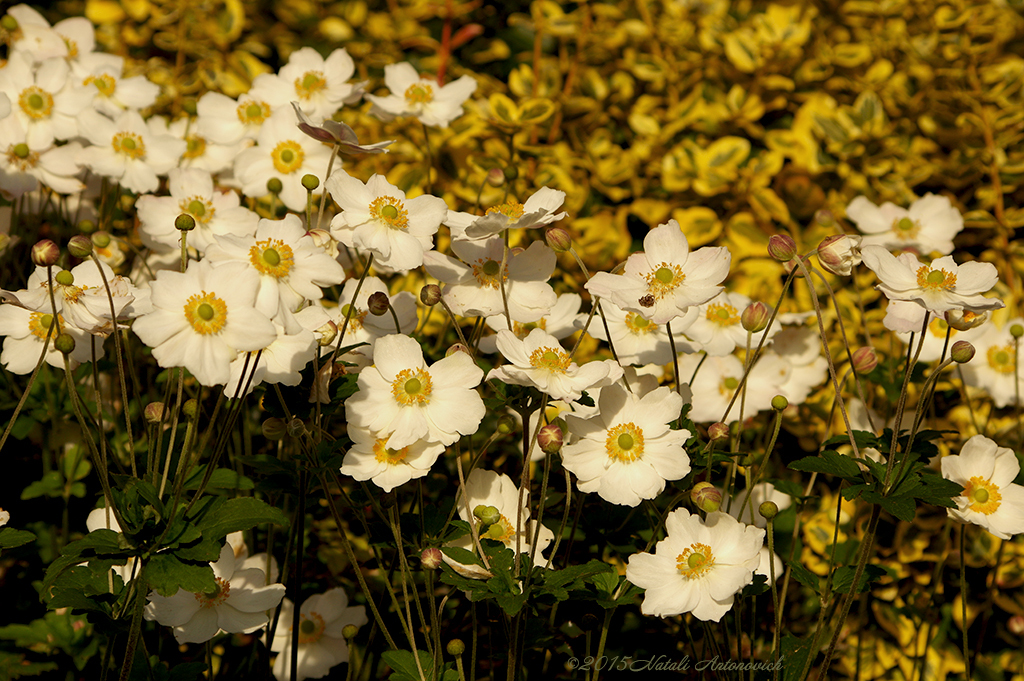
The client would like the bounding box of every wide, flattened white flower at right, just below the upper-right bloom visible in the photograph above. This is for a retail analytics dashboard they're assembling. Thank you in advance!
[861,246,1004,314]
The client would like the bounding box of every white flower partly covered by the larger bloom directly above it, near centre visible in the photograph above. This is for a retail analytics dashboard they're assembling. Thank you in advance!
[341,427,444,492]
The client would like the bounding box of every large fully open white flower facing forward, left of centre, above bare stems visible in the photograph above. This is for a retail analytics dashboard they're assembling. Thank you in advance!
[132,260,278,386]
